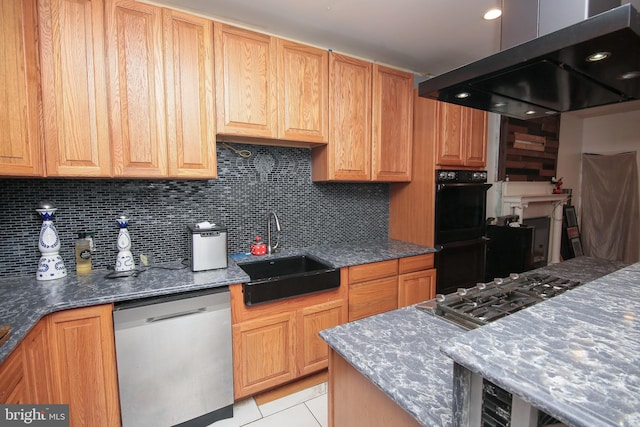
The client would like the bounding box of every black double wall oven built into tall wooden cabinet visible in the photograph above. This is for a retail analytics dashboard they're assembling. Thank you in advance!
[435,170,491,294]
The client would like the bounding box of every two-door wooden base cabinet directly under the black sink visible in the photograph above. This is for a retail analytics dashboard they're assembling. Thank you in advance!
[229,269,347,400]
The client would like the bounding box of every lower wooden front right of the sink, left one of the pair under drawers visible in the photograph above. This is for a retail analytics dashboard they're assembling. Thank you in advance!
[349,276,398,322]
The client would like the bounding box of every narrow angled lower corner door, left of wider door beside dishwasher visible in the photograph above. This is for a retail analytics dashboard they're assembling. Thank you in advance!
[20,320,56,404]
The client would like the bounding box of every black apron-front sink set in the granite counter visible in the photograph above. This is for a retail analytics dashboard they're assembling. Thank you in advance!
[238,255,340,305]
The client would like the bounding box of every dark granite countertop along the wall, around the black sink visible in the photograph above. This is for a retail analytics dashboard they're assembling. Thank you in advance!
[0,239,435,363]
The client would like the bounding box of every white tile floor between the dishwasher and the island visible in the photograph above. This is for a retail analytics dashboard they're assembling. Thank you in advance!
[209,383,329,427]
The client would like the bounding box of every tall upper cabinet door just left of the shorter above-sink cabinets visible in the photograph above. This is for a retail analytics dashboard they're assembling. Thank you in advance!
[164,9,216,178]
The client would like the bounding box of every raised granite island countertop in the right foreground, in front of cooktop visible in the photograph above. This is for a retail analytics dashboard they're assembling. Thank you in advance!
[442,263,640,427]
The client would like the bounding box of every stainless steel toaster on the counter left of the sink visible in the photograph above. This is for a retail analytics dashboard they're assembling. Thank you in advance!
[187,224,227,271]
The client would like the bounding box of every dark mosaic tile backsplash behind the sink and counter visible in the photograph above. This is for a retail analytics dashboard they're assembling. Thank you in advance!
[0,144,389,277]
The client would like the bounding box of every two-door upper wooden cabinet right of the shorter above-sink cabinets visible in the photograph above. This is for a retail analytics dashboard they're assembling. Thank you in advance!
[312,53,413,181]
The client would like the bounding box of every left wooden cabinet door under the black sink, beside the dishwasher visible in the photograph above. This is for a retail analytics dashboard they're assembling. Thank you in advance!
[233,312,295,399]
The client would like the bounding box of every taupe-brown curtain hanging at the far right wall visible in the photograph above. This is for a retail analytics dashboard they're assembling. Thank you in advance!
[581,151,640,262]
